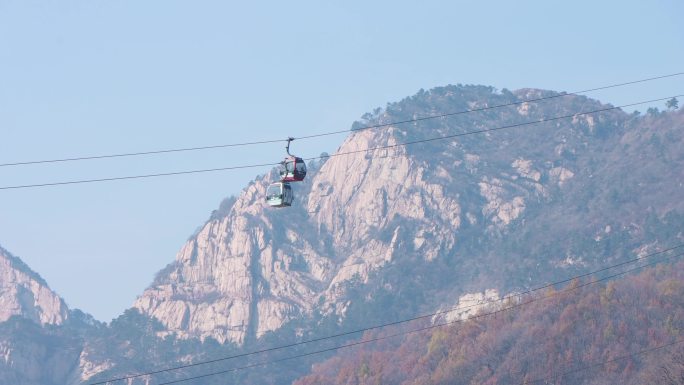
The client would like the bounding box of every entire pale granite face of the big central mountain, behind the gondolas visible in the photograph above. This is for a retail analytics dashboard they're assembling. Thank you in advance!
[134,115,472,344]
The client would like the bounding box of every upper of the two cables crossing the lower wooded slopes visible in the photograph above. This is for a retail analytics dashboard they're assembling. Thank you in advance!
[89,244,684,385]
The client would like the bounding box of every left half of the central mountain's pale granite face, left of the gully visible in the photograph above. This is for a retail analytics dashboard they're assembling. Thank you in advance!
[134,179,329,343]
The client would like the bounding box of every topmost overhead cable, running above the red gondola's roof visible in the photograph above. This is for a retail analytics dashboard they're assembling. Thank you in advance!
[0,72,684,167]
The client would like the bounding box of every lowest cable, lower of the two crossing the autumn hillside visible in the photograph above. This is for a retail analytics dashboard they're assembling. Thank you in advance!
[150,248,684,385]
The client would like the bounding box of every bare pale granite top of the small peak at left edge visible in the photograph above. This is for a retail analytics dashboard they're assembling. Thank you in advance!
[0,248,69,325]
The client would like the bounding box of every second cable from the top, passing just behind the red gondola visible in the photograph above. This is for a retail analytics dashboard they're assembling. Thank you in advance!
[0,95,684,190]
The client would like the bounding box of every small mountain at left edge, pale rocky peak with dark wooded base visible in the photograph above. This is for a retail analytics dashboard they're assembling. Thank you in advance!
[0,248,87,385]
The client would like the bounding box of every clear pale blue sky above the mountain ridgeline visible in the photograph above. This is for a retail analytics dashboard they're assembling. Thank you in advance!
[0,0,684,322]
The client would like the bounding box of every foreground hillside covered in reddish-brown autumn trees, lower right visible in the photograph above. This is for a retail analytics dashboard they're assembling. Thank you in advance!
[295,261,684,385]
